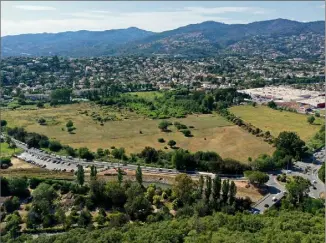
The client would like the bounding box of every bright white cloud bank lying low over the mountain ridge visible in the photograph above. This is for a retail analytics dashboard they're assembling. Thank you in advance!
[1,7,268,36]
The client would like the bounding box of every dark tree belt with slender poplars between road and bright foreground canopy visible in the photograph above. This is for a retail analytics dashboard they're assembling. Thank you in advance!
[1,169,251,238]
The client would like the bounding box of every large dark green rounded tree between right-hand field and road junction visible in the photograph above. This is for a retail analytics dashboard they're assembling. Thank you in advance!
[275,132,307,159]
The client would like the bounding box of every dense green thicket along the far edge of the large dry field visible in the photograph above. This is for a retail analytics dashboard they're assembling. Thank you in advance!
[97,88,247,120]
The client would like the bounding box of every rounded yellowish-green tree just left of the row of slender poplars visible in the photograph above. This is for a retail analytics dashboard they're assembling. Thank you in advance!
[172,173,195,204]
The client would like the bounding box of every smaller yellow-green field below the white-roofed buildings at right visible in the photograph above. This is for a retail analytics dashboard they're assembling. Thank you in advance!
[230,105,324,141]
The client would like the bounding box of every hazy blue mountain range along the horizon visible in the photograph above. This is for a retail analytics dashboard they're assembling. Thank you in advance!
[1,19,325,57]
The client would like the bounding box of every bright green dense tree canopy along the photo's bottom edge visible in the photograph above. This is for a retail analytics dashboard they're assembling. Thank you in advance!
[4,207,325,243]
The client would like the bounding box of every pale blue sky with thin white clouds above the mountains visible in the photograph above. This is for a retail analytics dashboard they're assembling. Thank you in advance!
[1,1,325,36]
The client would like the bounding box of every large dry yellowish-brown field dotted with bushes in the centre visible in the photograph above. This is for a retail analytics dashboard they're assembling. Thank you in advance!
[2,103,273,161]
